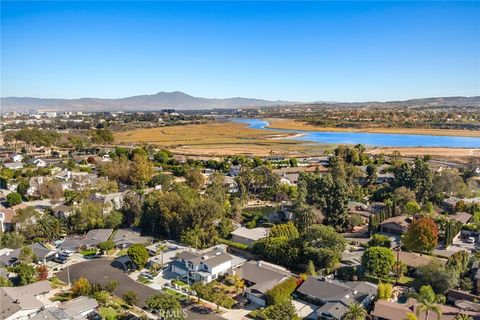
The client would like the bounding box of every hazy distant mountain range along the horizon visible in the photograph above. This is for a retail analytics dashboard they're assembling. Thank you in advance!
[0,91,480,112]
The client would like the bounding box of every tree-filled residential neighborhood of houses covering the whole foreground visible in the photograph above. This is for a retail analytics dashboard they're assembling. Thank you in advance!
[0,133,480,320]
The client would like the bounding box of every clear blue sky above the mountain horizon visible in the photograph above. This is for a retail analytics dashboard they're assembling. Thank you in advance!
[1,1,480,101]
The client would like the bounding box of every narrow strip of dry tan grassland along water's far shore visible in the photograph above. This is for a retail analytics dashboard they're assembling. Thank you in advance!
[267,119,480,137]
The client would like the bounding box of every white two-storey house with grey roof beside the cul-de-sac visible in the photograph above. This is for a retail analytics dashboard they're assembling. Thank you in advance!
[170,245,245,282]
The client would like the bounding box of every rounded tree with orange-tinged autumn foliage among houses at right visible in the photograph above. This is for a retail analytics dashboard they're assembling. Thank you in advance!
[403,217,438,252]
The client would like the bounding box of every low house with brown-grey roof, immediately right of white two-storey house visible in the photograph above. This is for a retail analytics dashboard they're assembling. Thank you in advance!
[231,260,292,307]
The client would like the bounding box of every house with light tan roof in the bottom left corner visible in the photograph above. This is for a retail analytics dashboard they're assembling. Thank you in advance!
[0,280,52,320]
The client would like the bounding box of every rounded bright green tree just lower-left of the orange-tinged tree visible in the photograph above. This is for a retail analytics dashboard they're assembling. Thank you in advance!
[362,247,395,277]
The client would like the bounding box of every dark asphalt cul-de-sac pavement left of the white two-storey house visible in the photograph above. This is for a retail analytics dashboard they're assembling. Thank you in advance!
[58,258,158,308]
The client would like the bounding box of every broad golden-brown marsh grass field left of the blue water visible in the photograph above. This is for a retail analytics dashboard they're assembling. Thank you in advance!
[115,122,328,156]
